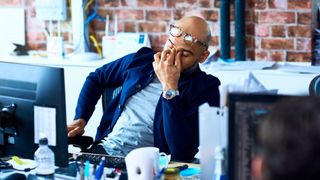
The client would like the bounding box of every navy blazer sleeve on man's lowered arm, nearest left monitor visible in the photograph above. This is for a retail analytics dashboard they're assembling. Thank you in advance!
[74,48,154,122]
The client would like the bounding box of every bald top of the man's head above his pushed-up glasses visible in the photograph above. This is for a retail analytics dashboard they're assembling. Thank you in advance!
[176,16,211,45]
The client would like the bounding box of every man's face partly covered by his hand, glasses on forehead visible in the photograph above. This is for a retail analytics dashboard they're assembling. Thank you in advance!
[164,25,206,71]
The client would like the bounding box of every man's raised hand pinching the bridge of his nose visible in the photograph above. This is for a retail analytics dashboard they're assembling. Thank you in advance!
[152,48,181,91]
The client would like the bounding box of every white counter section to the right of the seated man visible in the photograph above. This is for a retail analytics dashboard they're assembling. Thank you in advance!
[203,63,320,106]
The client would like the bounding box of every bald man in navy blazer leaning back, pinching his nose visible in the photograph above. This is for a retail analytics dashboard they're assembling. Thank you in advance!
[68,16,220,160]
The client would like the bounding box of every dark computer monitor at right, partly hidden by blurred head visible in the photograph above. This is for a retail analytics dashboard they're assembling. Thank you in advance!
[227,93,289,180]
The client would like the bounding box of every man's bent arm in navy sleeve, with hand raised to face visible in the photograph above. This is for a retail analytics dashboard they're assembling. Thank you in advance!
[153,48,220,160]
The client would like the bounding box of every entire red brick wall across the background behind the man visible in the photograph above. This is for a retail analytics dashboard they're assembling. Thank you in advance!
[0,0,312,61]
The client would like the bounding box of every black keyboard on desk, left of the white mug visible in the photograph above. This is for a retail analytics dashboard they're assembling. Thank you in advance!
[77,152,126,170]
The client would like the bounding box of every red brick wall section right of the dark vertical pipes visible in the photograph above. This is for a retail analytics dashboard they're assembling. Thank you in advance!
[248,0,312,62]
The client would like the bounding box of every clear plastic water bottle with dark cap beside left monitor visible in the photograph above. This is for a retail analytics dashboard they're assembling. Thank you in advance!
[34,137,55,175]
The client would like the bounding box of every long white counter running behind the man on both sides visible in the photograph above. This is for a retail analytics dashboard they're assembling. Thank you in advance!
[0,56,318,136]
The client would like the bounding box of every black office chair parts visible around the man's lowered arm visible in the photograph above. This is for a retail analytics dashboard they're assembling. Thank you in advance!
[68,86,122,151]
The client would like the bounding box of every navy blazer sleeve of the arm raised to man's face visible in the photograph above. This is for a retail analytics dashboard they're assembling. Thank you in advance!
[162,76,220,161]
